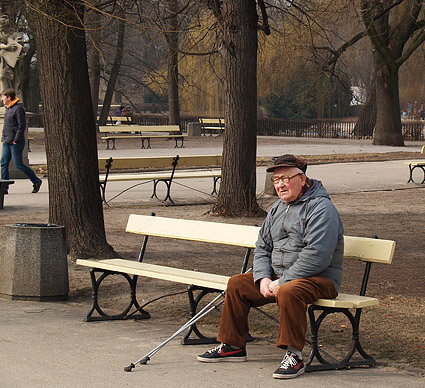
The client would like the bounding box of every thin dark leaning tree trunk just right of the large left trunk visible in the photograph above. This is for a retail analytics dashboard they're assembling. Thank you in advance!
[99,7,125,125]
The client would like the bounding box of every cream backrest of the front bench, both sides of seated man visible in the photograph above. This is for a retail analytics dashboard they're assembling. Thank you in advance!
[126,214,395,264]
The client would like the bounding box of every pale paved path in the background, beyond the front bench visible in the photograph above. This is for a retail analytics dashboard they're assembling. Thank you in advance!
[3,138,422,212]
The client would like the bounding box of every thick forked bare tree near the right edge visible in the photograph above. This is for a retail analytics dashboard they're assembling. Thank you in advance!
[361,0,425,146]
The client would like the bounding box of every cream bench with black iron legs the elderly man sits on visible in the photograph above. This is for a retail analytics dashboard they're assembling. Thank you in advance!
[77,214,395,371]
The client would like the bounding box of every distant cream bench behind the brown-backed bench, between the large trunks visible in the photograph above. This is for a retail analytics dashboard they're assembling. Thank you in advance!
[99,125,185,150]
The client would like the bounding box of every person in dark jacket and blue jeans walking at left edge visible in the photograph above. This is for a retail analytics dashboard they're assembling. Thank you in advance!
[1,89,42,194]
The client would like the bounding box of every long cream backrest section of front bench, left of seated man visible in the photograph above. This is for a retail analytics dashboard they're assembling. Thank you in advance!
[126,214,260,248]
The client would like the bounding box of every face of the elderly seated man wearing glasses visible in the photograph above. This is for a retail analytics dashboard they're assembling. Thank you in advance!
[273,167,306,203]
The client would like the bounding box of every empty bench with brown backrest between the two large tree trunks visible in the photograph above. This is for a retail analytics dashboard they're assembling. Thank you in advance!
[98,155,222,204]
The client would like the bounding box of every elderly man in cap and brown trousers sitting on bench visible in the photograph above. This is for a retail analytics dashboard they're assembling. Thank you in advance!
[197,154,344,379]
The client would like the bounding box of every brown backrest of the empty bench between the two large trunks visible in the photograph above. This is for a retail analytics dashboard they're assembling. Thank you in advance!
[98,155,223,169]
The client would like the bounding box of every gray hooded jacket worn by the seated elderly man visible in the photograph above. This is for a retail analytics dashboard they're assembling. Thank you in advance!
[254,179,344,291]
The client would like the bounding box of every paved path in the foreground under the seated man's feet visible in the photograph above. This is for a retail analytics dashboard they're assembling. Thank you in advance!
[0,299,425,388]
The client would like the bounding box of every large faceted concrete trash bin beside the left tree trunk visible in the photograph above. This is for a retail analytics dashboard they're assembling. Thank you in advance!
[0,223,69,301]
